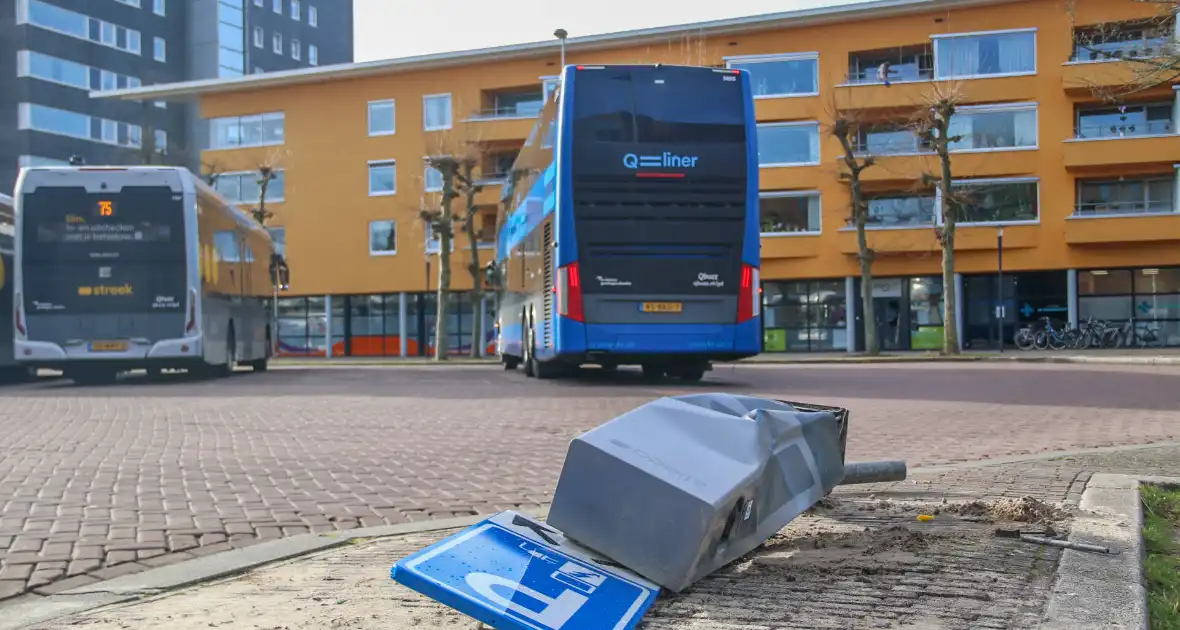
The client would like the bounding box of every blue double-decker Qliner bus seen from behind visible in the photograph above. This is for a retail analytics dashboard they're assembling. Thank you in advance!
[490,65,761,381]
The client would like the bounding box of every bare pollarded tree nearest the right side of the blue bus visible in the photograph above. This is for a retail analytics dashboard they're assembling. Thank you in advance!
[828,103,880,355]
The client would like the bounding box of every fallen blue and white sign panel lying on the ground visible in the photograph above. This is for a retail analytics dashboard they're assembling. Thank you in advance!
[391,511,660,630]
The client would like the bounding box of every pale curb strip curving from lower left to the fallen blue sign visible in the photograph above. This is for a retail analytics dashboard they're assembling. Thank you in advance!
[0,508,548,630]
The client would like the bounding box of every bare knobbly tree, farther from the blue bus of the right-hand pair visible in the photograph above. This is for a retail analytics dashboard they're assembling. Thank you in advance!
[913,84,962,354]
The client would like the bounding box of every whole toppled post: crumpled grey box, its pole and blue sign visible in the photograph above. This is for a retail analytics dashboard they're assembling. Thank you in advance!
[391,394,863,630]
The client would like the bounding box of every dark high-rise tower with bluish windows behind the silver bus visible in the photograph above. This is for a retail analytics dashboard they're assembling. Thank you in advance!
[0,0,353,190]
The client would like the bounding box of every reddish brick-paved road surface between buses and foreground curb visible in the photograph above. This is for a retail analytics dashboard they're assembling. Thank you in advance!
[0,365,1180,598]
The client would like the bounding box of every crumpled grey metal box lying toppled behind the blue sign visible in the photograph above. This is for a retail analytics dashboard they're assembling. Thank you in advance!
[546,394,847,591]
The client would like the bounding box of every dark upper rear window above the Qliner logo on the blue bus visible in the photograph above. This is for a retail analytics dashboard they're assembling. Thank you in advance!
[573,67,746,144]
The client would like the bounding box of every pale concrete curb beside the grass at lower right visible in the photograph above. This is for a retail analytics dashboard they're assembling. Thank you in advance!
[1038,473,1165,630]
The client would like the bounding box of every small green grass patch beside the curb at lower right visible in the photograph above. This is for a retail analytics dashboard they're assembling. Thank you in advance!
[1140,485,1180,630]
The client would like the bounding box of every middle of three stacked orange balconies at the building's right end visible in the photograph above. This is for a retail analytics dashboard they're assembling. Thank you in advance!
[1063,127,1180,170]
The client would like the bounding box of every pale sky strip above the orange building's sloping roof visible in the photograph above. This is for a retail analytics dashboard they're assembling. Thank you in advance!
[354,0,850,61]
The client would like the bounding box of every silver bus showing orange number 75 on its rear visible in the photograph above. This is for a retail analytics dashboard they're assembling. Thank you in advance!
[12,166,289,383]
